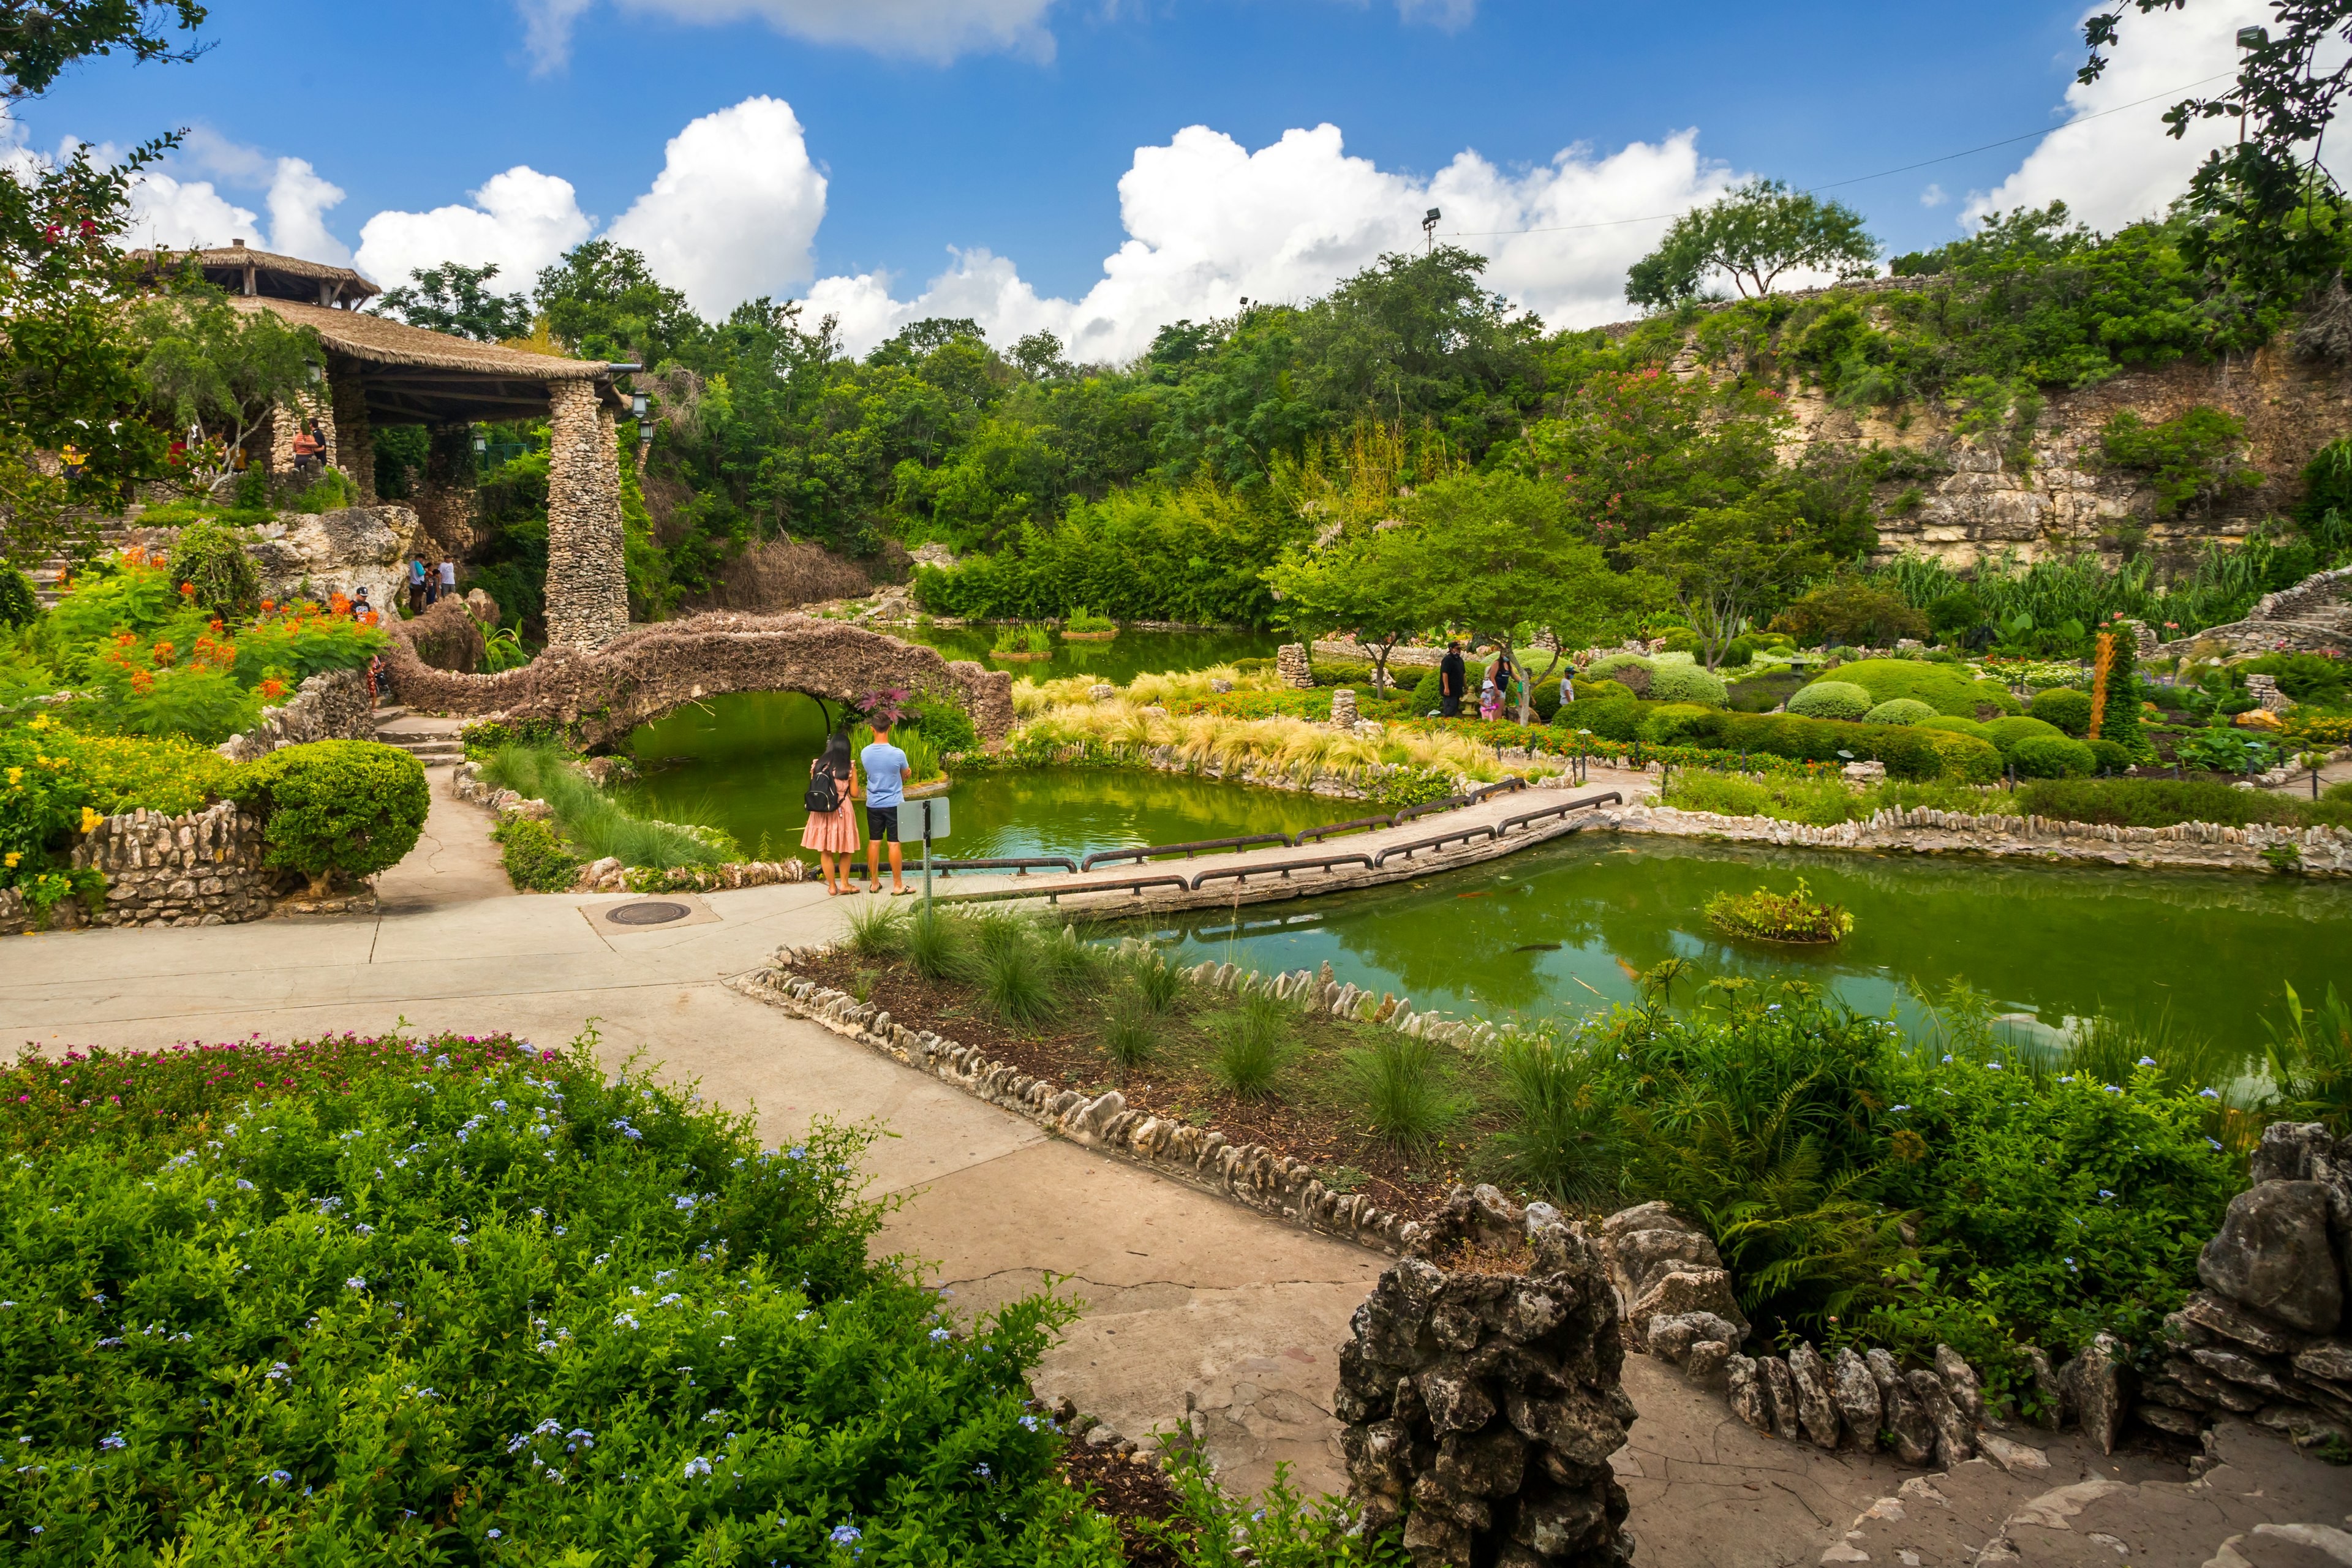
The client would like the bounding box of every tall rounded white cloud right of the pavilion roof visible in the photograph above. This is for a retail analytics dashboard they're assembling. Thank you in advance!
[609,96,826,315]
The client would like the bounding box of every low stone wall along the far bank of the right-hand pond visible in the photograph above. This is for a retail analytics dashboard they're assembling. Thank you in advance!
[1593,806,2352,877]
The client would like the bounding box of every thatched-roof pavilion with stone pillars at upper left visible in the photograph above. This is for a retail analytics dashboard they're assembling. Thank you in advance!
[132,239,628,646]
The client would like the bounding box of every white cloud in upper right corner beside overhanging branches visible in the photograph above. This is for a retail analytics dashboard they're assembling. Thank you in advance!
[1962,0,2272,233]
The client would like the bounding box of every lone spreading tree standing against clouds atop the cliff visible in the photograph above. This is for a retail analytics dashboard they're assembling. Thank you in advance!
[1625,179,1879,311]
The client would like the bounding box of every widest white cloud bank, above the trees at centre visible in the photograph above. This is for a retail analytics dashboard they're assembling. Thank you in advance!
[809,124,1731,362]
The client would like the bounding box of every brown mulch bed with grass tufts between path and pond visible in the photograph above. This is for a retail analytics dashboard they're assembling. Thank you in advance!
[800,952,1501,1220]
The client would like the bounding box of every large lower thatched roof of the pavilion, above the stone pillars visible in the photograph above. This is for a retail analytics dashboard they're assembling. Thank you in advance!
[228,296,628,426]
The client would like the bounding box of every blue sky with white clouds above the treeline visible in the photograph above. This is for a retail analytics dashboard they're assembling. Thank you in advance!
[19,0,2260,357]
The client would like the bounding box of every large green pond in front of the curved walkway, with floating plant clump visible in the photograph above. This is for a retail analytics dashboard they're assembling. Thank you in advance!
[1115,832,2352,1055]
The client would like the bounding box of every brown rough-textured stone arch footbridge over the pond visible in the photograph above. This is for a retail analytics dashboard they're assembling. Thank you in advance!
[383,614,1014,750]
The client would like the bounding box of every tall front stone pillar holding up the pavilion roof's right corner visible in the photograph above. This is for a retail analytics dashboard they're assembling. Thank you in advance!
[548,381,628,649]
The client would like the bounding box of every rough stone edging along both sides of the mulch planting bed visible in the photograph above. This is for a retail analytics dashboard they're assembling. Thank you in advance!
[725,948,1449,1257]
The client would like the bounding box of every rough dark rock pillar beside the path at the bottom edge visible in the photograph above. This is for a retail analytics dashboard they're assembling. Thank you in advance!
[1333,1187,1635,1568]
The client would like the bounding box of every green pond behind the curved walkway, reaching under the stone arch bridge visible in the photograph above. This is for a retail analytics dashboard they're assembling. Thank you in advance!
[621,691,1360,861]
